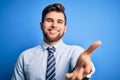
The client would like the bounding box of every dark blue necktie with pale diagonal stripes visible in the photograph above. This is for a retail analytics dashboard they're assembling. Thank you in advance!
[46,47,56,80]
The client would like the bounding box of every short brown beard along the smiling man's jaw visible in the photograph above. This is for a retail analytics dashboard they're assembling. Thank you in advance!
[42,30,64,42]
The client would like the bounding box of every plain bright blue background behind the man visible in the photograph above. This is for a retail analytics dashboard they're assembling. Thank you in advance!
[0,0,120,80]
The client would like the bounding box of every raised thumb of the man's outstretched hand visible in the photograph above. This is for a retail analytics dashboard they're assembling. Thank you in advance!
[86,41,102,55]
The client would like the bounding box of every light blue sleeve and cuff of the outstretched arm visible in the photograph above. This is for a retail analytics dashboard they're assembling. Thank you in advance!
[71,46,95,78]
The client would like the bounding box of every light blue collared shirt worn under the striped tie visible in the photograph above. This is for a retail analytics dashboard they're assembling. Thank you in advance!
[12,41,94,80]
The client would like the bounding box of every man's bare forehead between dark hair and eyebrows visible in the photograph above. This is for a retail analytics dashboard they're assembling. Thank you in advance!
[45,11,65,21]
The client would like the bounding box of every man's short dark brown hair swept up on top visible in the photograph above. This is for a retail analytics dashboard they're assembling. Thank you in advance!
[42,3,67,25]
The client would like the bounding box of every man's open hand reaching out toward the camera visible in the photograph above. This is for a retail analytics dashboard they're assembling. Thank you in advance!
[65,41,101,80]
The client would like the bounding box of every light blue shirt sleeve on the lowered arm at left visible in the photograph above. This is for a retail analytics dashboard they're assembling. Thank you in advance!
[11,54,25,80]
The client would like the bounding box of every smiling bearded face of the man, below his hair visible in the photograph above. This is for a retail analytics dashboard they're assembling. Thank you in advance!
[41,11,66,42]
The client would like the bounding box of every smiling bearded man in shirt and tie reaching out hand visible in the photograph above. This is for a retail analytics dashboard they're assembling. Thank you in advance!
[12,3,101,80]
